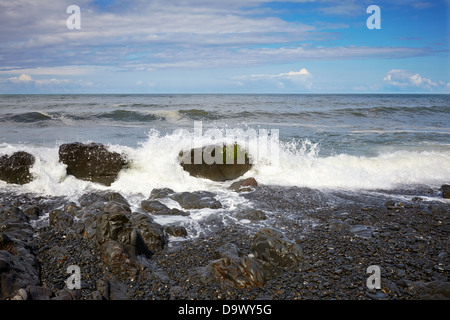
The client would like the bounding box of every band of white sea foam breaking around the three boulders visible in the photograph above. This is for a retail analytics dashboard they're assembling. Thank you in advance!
[0,130,450,198]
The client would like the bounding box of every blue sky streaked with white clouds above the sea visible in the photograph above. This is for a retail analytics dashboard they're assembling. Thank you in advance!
[0,0,450,94]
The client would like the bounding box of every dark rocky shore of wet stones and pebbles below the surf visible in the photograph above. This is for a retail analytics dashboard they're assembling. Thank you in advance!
[0,181,450,300]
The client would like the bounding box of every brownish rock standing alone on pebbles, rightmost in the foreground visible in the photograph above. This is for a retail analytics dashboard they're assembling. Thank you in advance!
[250,228,304,270]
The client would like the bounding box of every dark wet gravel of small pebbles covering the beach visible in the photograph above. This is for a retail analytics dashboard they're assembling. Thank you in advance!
[0,185,450,300]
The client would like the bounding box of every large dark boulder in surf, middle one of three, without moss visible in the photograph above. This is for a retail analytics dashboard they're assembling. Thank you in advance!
[59,142,127,186]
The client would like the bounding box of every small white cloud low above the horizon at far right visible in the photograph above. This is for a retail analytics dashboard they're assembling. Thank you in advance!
[384,69,443,89]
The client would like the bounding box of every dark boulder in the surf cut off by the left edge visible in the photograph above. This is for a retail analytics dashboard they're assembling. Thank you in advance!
[0,151,36,184]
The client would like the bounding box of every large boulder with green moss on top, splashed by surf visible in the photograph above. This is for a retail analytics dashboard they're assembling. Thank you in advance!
[179,144,252,181]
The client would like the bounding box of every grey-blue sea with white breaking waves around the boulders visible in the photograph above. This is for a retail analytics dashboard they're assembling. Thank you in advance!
[0,94,450,234]
